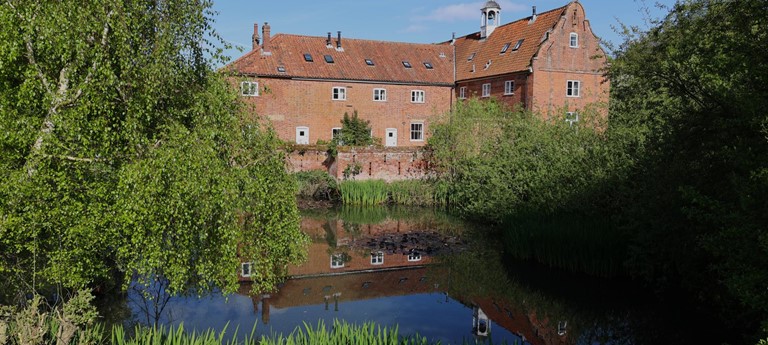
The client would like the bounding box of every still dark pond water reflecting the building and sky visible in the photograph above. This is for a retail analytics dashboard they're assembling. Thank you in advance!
[102,208,726,344]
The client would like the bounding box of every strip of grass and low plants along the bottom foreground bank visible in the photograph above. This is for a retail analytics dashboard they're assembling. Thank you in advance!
[0,291,468,345]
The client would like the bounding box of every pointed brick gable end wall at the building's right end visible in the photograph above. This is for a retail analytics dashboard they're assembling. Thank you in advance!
[532,2,609,117]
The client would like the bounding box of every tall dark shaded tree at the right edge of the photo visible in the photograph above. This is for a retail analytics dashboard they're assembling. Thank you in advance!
[610,0,768,342]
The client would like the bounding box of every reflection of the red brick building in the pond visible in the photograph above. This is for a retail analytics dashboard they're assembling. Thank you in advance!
[240,212,567,344]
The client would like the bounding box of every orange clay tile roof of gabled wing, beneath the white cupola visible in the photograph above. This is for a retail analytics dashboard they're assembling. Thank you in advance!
[456,5,568,80]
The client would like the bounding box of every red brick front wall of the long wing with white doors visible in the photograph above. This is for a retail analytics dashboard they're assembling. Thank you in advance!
[238,78,453,146]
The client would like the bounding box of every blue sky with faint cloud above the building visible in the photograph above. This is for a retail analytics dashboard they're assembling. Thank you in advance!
[213,0,675,58]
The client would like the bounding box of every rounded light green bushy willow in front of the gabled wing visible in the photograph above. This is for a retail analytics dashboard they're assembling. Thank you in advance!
[429,99,615,221]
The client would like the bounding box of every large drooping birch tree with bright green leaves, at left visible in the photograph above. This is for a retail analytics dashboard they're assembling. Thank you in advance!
[0,0,306,300]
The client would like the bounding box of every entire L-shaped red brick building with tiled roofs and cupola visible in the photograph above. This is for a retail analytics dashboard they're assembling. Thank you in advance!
[227,1,608,146]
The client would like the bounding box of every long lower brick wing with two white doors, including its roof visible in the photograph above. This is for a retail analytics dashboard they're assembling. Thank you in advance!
[229,23,453,146]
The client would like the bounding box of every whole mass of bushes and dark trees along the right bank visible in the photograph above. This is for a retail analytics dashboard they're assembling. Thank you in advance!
[429,0,768,343]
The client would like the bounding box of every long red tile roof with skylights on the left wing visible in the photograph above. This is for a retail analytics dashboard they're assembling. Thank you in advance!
[227,34,453,85]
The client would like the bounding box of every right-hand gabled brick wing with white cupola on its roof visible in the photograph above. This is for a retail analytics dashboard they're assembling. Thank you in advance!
[455,1,610,120]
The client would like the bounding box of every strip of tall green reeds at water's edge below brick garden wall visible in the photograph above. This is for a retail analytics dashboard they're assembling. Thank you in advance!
[340,180,448,206]
